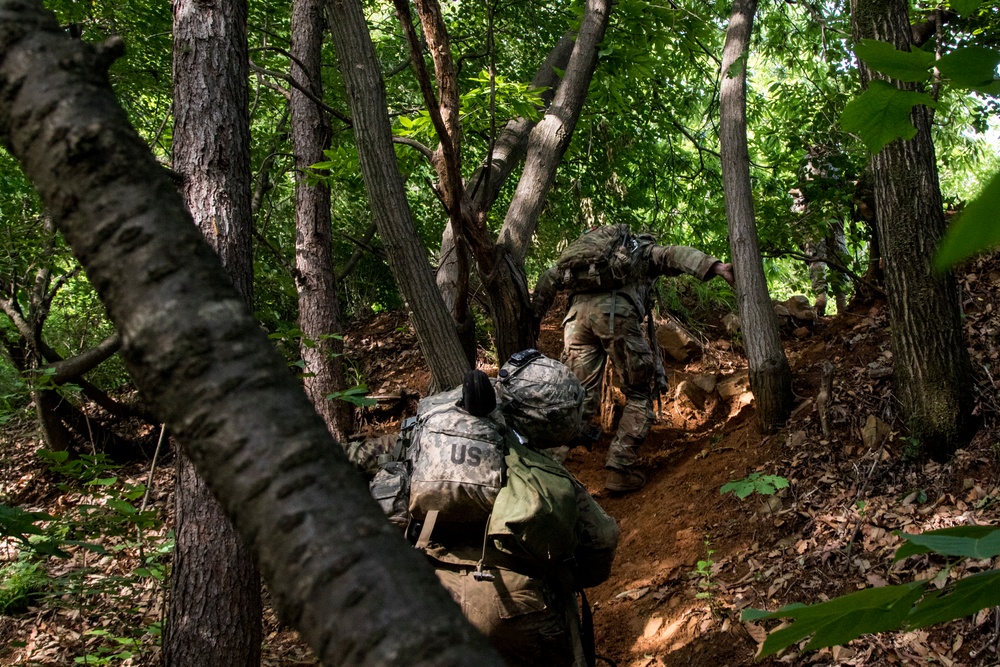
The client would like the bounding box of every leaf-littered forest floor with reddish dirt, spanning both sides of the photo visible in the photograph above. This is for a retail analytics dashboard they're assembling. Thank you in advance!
[0,256,1000,667]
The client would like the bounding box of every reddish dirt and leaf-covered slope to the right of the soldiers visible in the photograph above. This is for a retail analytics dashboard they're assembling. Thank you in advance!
[348,258,1000,667]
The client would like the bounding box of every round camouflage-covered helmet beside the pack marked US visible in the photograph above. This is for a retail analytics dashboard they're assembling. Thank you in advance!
[496,349,584,449]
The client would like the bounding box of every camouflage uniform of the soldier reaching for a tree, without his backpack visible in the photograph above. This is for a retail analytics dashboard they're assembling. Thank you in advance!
[532,245,721,470]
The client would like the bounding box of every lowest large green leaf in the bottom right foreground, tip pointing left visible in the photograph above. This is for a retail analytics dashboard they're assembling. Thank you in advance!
[740,581,927,658]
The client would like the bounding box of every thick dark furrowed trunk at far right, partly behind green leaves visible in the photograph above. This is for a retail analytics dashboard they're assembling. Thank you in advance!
[851,0,972,460]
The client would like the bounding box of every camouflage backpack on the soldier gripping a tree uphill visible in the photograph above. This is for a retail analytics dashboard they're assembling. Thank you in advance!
[556,224,651,292]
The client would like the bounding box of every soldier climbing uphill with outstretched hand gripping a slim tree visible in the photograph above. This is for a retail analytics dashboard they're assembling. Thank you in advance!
[532,225,733,493]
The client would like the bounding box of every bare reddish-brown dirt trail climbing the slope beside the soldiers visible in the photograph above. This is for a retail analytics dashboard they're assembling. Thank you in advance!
[540,320,767,667]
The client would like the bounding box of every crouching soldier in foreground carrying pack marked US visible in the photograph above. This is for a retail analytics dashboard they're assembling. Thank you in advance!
[362,360,619,667]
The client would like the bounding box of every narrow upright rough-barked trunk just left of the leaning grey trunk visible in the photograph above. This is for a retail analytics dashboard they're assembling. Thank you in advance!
[289,0,351,439]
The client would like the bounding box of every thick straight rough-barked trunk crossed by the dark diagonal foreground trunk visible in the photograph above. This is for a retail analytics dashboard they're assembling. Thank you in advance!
[164,0,261,667]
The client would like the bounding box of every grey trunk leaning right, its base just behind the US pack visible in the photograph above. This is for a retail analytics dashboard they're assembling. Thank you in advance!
[329,0,469,389]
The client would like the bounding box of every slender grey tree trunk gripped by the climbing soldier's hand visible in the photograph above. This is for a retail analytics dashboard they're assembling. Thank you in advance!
[719,0,792,432]
